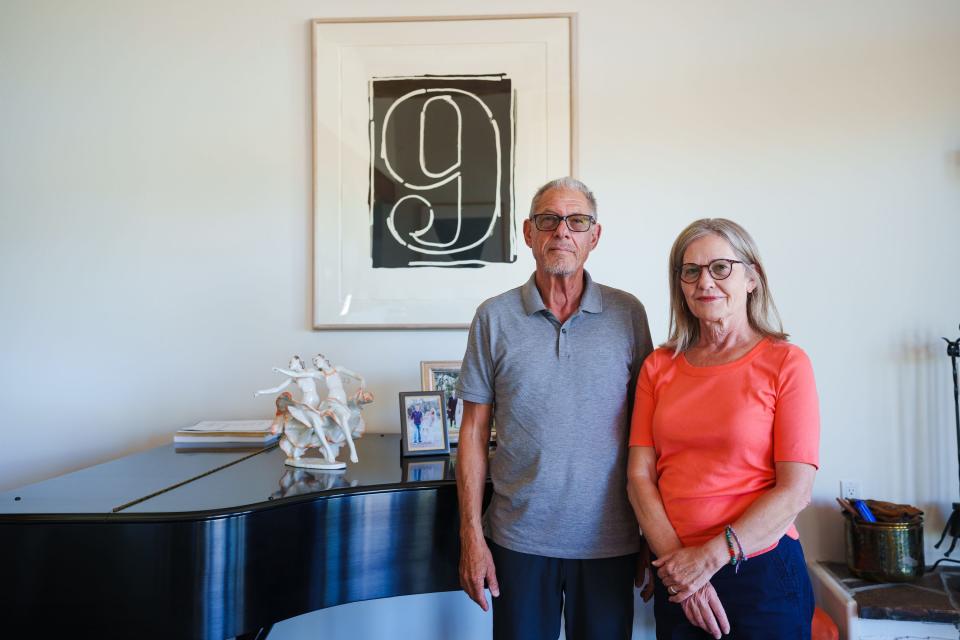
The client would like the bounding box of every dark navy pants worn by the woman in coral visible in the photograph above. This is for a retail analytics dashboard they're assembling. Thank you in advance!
[653,536,814,640]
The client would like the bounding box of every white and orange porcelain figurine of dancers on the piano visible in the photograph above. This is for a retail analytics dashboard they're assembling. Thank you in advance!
[255,355,373,469]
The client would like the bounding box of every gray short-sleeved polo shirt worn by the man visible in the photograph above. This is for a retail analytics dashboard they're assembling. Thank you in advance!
[457,274,652,559]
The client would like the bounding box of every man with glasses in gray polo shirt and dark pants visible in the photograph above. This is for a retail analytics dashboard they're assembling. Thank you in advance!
[457,178,652,640]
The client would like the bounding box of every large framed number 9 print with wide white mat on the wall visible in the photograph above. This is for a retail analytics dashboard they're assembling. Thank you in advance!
[313,14,575,329]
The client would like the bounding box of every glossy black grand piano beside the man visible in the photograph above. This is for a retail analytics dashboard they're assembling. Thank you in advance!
[0,434,489,640]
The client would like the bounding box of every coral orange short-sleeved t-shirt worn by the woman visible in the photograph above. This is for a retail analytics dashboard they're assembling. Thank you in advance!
[630,338,820,546]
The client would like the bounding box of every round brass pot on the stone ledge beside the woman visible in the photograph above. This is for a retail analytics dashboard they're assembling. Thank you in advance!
[843,513,924,582]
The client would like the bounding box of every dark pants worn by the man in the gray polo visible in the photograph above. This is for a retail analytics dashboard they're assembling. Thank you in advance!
[487,540,637,640]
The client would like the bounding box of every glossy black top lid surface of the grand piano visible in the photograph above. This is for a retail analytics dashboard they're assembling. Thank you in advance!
[0,434,455,521]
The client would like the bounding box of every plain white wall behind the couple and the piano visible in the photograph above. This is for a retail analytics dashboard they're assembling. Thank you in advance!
[0,0,960,636]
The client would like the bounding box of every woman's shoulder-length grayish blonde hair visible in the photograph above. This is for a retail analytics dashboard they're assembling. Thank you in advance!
[663,218,789,353]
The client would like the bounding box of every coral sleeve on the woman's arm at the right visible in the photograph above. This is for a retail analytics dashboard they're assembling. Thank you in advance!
[773,347,820,468]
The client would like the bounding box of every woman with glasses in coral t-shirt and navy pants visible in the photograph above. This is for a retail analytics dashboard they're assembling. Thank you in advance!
[628,218,820,640]
